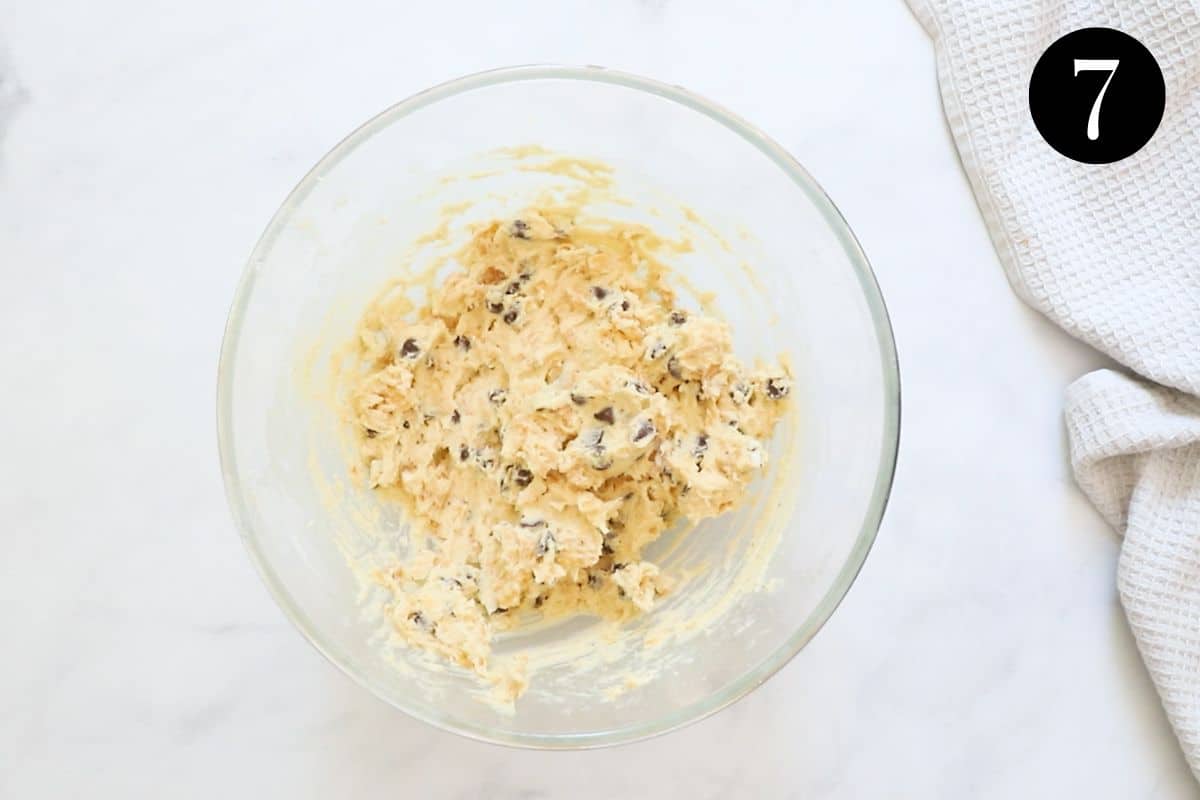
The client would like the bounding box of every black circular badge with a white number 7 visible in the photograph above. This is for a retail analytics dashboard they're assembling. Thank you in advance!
[1030,28,1166,164]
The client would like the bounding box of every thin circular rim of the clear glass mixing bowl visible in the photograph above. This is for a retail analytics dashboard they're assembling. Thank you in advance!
[216,64,901,750]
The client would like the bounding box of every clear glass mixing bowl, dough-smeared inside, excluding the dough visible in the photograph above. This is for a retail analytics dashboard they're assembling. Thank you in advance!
[217,66,900,748]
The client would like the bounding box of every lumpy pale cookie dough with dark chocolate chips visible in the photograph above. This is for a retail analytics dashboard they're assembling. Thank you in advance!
[350,209,791,697]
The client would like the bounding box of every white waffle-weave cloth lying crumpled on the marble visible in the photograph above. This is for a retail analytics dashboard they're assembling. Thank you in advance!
[908,0,1200,777]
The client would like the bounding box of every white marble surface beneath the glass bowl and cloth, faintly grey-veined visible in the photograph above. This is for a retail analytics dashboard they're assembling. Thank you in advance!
[0,0,1196,800]
